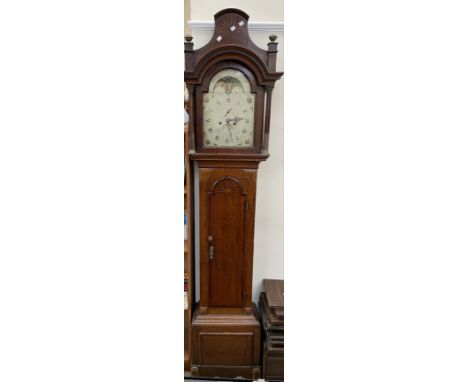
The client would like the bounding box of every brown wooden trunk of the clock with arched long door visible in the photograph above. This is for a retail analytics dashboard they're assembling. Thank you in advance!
[199,163,257,312]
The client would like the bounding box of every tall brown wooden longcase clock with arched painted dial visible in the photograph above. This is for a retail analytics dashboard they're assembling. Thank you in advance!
[184,9,282,378]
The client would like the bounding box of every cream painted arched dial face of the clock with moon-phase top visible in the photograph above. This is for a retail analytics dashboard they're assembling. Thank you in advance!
[203,69,255,148]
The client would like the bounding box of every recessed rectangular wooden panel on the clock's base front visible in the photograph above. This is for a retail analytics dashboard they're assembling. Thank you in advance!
[199,332,254,366]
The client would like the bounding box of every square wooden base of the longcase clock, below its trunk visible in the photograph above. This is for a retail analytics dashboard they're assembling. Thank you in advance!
[191,305,261,379]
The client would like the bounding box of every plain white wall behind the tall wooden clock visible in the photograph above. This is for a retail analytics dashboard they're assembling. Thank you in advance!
[191,0,284,302]
